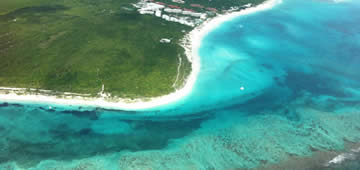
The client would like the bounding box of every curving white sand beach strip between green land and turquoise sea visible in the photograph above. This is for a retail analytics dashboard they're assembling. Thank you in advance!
[0,0,282,110]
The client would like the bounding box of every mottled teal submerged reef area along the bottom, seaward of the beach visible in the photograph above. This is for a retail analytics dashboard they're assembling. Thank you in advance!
[0,94,360,169]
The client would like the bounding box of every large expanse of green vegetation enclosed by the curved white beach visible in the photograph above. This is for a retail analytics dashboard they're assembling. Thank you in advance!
[0,0,191,97]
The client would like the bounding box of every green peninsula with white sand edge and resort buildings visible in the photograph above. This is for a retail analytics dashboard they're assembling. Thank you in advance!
[0,0,270,108]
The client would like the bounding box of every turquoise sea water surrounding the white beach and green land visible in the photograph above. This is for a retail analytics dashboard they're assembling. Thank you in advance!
[0,0,360,169]
